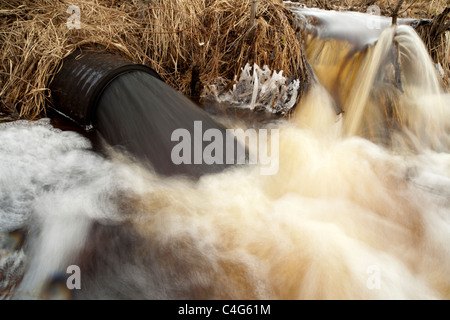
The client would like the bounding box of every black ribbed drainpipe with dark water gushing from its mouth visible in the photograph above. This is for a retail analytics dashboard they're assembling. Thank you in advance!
[49,50,239,178]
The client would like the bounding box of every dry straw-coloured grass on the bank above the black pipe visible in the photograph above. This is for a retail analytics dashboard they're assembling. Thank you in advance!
[0,0,306,119]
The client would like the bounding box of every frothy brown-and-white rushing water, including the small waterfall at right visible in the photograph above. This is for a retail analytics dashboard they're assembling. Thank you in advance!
[0,6,450,299]
